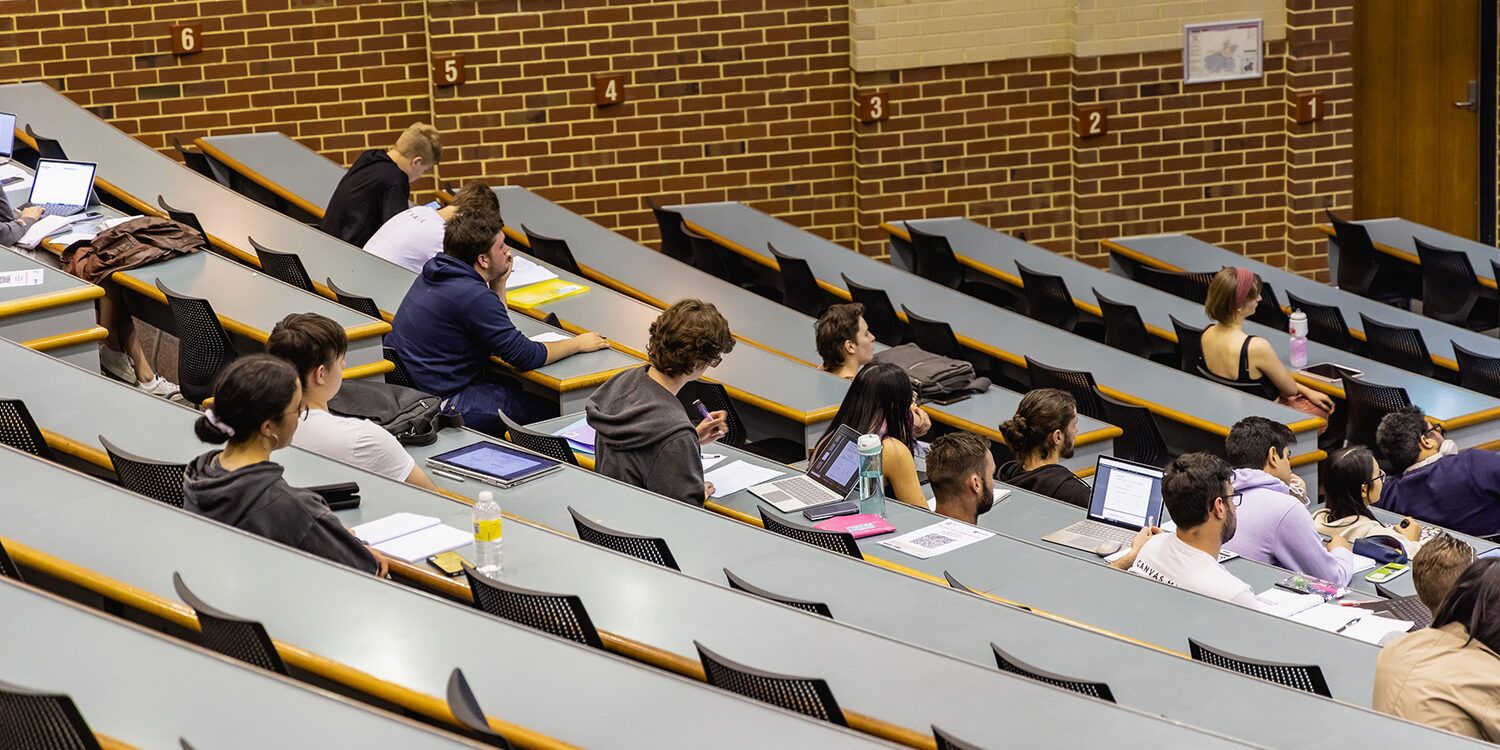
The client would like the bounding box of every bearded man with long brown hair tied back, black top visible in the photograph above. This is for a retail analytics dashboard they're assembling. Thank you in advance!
[1001,389,1094,509]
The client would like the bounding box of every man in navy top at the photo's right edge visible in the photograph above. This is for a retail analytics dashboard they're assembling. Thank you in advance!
[1376,407,1500,537]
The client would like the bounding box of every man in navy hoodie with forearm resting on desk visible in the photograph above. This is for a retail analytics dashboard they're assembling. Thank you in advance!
[386,213,609,435]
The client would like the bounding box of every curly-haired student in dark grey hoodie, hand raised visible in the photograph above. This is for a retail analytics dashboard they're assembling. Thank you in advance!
[584,300,735,506]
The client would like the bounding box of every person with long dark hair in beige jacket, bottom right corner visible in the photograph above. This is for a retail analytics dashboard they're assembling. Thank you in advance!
[1373,560,1500,743]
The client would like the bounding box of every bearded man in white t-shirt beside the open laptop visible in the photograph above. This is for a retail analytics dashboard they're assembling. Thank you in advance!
[1130,453,1260,609]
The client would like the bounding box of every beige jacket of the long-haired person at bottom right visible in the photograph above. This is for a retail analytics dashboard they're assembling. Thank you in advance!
[1374,623,1500,743]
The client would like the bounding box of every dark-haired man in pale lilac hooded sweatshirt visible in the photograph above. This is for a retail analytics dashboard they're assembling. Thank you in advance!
[1224,417,1355,587]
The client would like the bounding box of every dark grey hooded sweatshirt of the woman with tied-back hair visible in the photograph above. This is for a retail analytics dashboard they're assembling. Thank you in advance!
[183,450,375,573]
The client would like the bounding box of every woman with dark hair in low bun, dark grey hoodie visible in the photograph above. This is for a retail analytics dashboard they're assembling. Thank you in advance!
[183,354,386,576]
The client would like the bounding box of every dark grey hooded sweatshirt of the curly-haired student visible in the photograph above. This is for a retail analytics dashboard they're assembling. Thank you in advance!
[584,368,704,506]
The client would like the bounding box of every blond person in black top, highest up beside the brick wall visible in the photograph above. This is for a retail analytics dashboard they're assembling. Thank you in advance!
[318,123,443,248]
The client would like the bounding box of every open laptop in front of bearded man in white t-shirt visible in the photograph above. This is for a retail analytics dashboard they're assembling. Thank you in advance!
[1041,456,1161,552]
